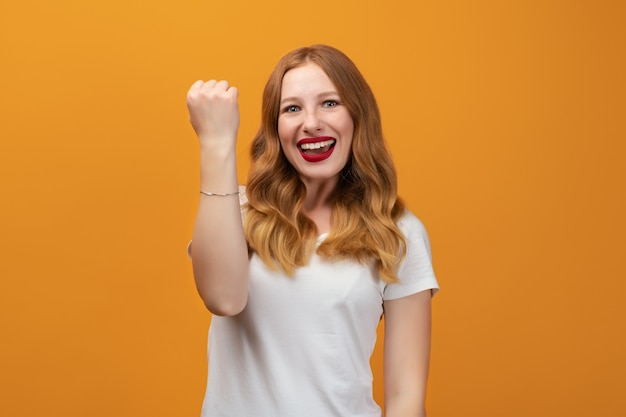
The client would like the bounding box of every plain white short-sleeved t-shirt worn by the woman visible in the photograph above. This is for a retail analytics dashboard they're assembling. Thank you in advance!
[197,196,438,417]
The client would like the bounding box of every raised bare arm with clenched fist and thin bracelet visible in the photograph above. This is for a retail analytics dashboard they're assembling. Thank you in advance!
[187,80,248,316]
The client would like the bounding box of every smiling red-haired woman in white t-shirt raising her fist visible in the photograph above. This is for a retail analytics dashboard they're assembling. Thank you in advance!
[187,45,438,417]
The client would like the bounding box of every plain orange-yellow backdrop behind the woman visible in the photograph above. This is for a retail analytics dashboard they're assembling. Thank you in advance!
[0,0,626,417]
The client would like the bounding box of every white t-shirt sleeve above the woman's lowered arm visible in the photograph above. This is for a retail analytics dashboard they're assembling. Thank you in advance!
[383,211,439,300]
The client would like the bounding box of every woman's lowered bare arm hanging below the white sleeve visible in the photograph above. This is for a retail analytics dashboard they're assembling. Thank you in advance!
[384,290,432,417]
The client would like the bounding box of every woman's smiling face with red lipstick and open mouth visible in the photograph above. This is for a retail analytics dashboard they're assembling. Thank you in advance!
[278,63,354,188]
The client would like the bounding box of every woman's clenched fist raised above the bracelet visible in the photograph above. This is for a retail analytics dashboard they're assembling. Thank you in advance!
[187,80,239,147]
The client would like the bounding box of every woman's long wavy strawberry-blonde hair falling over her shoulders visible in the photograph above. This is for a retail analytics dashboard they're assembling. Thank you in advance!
[244,45,406,282]
